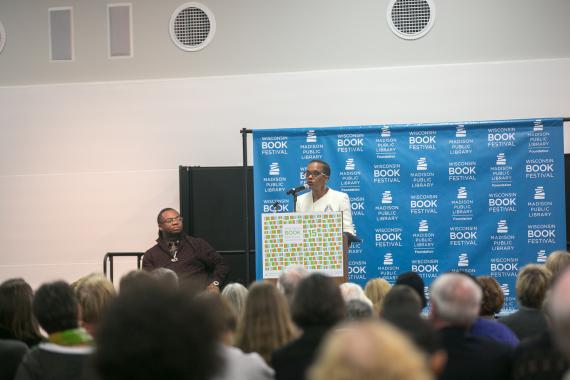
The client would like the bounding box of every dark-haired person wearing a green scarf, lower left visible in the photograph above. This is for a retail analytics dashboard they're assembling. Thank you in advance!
[15,281,93,380]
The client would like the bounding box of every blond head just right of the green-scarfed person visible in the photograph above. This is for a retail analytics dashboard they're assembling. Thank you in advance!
[72,273,117,336]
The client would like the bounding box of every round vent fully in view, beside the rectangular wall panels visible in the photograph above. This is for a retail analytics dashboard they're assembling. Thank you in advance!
[170,3,216,51]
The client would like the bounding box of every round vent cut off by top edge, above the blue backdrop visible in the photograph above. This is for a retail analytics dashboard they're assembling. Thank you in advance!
[386,0,435,40]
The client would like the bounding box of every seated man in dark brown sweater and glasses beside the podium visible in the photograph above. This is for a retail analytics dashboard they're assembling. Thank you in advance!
[142,208,228,292]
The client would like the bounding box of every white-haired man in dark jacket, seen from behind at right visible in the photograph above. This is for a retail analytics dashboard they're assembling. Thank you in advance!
[430,273,512,380]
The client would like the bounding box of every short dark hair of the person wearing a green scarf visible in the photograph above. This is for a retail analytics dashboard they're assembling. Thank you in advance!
[34,281,79,334]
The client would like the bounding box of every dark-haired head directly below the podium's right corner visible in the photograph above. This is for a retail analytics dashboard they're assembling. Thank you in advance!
[291,273,344,328]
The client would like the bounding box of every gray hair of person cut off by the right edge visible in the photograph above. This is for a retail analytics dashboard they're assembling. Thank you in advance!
[547,269,570,359]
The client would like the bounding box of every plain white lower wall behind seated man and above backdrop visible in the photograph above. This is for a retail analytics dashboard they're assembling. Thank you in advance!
[0,59,570,286]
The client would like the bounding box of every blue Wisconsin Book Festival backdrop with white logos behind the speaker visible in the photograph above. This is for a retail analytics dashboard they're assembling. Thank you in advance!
[253,119,566,311]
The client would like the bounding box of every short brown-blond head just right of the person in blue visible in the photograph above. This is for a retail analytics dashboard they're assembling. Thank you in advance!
[516,264,552,309]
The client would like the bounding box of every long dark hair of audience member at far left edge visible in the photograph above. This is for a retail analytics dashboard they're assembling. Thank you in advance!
[0,278,43,347]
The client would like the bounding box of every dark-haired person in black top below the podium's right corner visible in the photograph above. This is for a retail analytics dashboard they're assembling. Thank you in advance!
[271,273,345,380]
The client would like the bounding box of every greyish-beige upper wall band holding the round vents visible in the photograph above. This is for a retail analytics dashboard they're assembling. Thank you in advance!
[0,0,570,85]
